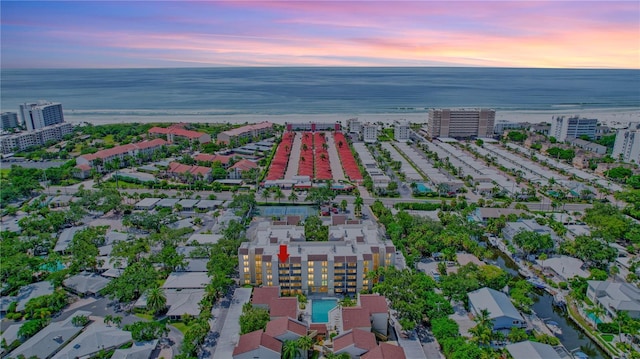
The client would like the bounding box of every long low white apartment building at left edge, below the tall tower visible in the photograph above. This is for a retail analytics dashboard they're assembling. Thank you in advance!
[0,123,73,154]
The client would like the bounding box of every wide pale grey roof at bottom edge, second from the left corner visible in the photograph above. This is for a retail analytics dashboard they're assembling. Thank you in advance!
[53,323,132,359]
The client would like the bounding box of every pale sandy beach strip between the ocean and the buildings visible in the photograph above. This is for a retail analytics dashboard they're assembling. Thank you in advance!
[65,108,640,127]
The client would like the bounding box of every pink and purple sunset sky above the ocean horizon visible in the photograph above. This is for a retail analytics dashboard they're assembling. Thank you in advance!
[0,0,640,69]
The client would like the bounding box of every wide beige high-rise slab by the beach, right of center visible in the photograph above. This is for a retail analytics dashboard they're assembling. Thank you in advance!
[427,108,496,138]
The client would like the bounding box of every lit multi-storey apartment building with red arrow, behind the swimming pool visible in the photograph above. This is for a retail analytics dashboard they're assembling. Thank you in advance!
[238,216,396,296]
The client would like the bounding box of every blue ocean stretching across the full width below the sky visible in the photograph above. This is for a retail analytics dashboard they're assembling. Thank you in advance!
[0,67,640,122]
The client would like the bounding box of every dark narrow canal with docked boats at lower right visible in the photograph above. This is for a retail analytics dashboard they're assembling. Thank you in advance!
[487,246,608,359]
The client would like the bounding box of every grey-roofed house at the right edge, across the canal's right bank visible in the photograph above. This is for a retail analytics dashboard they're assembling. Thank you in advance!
[587,280,640,319]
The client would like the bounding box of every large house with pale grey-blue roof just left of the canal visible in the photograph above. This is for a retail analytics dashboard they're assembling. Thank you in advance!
[467,287,527,330]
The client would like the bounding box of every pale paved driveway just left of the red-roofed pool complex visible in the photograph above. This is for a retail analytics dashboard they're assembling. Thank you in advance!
[213,288,251,359]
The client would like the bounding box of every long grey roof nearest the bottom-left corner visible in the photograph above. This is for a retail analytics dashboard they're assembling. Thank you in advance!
[9,311,91,358]
